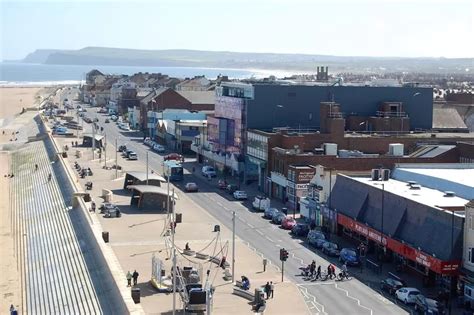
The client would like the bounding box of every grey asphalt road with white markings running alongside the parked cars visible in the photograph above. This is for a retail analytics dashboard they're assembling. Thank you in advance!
[68,89,407,315]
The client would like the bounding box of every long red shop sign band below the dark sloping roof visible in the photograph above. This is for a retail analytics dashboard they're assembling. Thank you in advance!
[337,213,460,275]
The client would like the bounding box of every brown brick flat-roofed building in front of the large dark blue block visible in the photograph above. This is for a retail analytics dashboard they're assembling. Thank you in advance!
[246,127,471,201]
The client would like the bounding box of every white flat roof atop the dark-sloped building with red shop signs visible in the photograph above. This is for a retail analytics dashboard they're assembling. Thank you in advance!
[353,177,469,209]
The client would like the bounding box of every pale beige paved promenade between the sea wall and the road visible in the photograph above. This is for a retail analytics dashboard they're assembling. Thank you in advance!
[52,113,309,314]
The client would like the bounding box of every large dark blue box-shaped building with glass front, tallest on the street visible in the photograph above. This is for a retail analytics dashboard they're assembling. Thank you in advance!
[196,81,433,186]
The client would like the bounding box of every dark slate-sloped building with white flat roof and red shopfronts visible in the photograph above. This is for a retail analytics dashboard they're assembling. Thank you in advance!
[330,175,468,289]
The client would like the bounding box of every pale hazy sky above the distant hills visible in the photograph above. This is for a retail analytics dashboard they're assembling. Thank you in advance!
[0,0,474,60]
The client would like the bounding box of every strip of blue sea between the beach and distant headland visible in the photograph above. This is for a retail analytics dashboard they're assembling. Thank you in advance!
[0,62,279,86]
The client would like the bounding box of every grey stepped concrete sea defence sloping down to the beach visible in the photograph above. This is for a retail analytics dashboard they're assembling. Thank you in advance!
[10,141,103,314]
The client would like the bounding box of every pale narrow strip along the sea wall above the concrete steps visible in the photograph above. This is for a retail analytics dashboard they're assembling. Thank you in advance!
[41,117,145,315]
